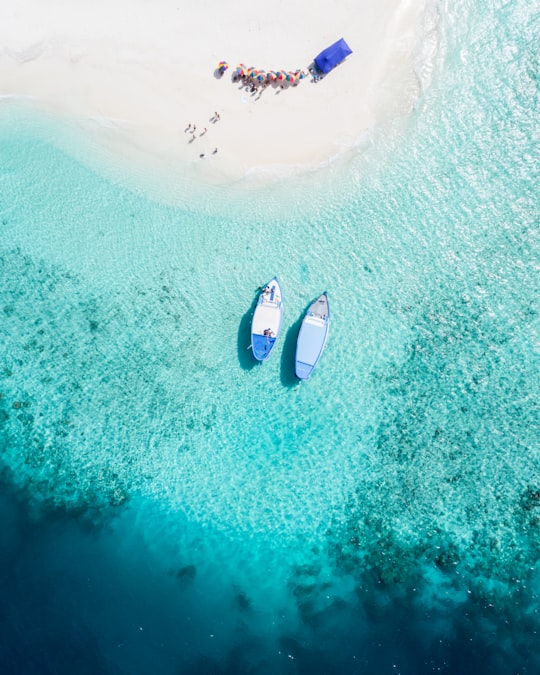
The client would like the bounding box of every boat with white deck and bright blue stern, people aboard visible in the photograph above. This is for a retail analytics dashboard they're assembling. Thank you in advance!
[251,277,283,361]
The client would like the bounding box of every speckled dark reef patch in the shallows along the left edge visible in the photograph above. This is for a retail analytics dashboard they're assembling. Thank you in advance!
[0,249,204,512]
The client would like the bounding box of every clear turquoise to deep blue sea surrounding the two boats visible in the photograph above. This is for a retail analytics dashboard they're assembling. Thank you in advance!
[0,0,540,674]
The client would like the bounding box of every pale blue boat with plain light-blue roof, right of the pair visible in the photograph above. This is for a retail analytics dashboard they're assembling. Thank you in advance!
[294,291,330,380]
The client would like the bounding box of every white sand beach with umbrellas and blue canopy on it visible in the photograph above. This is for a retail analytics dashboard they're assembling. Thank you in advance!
[0,0,426,183]
